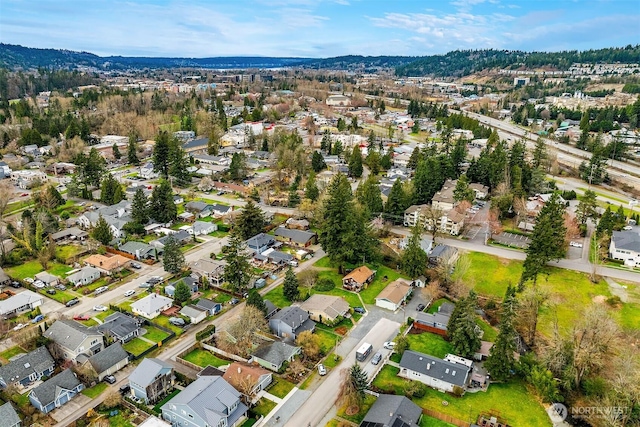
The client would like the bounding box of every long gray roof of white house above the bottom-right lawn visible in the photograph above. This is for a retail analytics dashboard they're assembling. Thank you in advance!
[400,350,469,387]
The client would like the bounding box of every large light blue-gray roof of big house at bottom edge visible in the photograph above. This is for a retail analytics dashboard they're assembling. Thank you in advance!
[162,376,247,426]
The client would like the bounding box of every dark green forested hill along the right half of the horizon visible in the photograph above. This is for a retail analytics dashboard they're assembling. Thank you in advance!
[396,45,640,77]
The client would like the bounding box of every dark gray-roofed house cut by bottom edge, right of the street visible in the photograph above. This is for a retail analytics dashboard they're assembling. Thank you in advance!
[360,394,422,427]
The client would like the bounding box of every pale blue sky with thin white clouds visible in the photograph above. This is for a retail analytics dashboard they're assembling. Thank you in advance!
[0,0,640,57]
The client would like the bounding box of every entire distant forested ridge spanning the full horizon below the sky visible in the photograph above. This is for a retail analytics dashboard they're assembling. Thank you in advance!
[0,43,640,77]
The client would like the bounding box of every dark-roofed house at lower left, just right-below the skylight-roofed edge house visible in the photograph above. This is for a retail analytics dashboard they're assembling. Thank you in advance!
[29,369,84,414]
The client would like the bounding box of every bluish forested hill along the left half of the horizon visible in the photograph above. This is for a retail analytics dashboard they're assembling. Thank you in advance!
[0,43,310,70]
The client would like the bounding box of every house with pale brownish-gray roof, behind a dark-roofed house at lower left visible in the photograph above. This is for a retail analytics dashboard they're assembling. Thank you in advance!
[42,319,104,362]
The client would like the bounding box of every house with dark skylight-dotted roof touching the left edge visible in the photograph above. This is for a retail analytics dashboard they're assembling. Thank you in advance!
[0,346,56,388]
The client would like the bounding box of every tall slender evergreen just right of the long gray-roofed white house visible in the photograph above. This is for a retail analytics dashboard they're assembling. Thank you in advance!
[484,286,517,381]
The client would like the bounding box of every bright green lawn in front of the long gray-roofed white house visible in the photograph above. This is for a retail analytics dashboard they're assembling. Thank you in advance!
[373,365,551,426]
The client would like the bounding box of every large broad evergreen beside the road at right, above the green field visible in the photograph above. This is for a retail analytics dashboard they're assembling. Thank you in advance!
[520,193,566,286]
